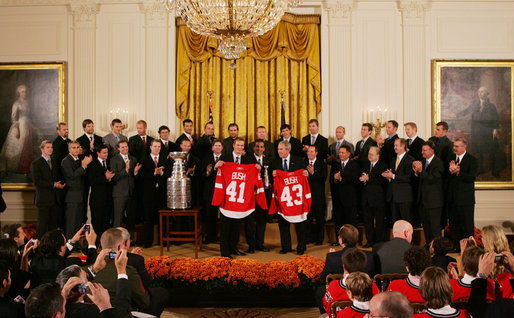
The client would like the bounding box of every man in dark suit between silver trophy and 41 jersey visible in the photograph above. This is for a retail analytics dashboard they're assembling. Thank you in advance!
[201,139,223,244]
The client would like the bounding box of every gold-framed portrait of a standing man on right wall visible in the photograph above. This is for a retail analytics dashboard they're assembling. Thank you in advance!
[432,60,514,189]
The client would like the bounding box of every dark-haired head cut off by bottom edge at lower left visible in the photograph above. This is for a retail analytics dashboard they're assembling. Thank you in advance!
[25,282,66,318]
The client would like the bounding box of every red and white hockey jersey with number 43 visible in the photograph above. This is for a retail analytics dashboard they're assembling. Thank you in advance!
[269,170,312,223]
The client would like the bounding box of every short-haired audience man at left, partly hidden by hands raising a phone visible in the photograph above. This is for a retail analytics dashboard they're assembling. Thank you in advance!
[94,228,168,317]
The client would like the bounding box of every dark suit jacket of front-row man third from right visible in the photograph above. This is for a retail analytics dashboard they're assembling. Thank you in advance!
[387,153,414,203]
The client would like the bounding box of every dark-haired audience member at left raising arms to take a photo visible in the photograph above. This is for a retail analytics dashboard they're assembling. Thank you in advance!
[30,226,96,286]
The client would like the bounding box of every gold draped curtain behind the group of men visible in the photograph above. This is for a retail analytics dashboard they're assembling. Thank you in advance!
[176,13,321,141]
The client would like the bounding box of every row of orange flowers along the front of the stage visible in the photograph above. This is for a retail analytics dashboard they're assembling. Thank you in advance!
[145,255,325,289]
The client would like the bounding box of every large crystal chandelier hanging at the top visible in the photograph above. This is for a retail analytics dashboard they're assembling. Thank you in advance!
[164,0,302,60]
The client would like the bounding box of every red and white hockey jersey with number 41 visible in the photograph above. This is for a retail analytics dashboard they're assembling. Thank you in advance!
[212,162,268,219]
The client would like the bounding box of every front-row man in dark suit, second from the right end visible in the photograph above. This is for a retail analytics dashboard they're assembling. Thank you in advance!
[412,140,444,245]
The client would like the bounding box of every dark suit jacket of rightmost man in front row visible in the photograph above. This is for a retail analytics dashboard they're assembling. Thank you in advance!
[448,152,478,205]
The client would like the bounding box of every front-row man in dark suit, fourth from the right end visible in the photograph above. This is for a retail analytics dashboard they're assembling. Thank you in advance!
[333,145,361,231]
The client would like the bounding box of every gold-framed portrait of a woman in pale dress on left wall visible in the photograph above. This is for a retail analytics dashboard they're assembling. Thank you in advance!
[0,62,66,190]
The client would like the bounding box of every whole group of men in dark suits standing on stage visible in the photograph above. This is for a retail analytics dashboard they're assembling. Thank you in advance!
[32,113,477,254]
